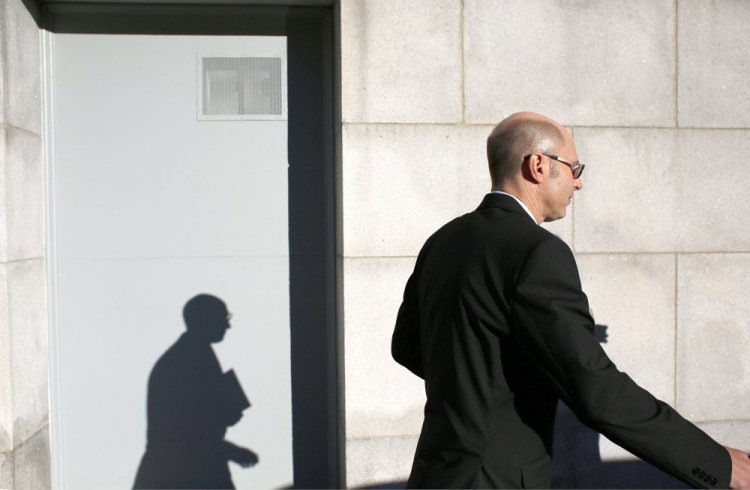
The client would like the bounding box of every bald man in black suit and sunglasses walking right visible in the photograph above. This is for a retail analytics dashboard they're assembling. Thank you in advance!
[392,113,750,488]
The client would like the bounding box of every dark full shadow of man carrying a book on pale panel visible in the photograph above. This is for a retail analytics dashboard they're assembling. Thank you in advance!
[133,294,258,488]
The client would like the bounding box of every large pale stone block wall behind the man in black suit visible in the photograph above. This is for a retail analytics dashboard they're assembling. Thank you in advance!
[339,0,750,487]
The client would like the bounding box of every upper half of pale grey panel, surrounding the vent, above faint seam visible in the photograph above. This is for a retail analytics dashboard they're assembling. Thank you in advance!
[53,34,288,257]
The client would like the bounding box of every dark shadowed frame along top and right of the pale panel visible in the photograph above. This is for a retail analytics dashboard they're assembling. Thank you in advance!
[43,0,346,488]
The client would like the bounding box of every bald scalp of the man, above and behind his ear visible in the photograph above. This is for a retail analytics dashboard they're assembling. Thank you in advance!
[487,112,565,189]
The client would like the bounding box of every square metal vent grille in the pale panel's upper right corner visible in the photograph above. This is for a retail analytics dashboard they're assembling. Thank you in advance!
[201,57,284,119]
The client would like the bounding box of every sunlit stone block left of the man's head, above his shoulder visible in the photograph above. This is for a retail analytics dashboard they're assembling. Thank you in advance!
[342,125,500,257]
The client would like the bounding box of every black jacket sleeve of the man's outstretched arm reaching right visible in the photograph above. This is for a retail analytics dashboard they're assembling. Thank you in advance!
[512,236,732,488]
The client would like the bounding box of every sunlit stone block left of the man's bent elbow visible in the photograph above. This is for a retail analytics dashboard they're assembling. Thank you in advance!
[344,258,425,437]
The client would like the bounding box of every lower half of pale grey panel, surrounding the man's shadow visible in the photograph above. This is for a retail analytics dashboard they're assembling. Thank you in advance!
[58,258,292,488]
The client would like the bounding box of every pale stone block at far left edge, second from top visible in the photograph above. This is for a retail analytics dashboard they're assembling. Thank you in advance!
[0,128,45,261]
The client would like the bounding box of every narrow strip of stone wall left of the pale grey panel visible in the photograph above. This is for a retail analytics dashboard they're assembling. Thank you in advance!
[0,0,50,490]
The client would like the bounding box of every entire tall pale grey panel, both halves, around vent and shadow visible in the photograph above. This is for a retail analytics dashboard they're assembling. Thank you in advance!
[50,34,293,489]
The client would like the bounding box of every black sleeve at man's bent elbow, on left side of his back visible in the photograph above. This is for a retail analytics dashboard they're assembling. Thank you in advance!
[391,272,424,378]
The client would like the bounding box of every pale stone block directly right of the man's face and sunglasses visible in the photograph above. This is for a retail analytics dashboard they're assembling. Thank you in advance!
[573,128,750,252]
